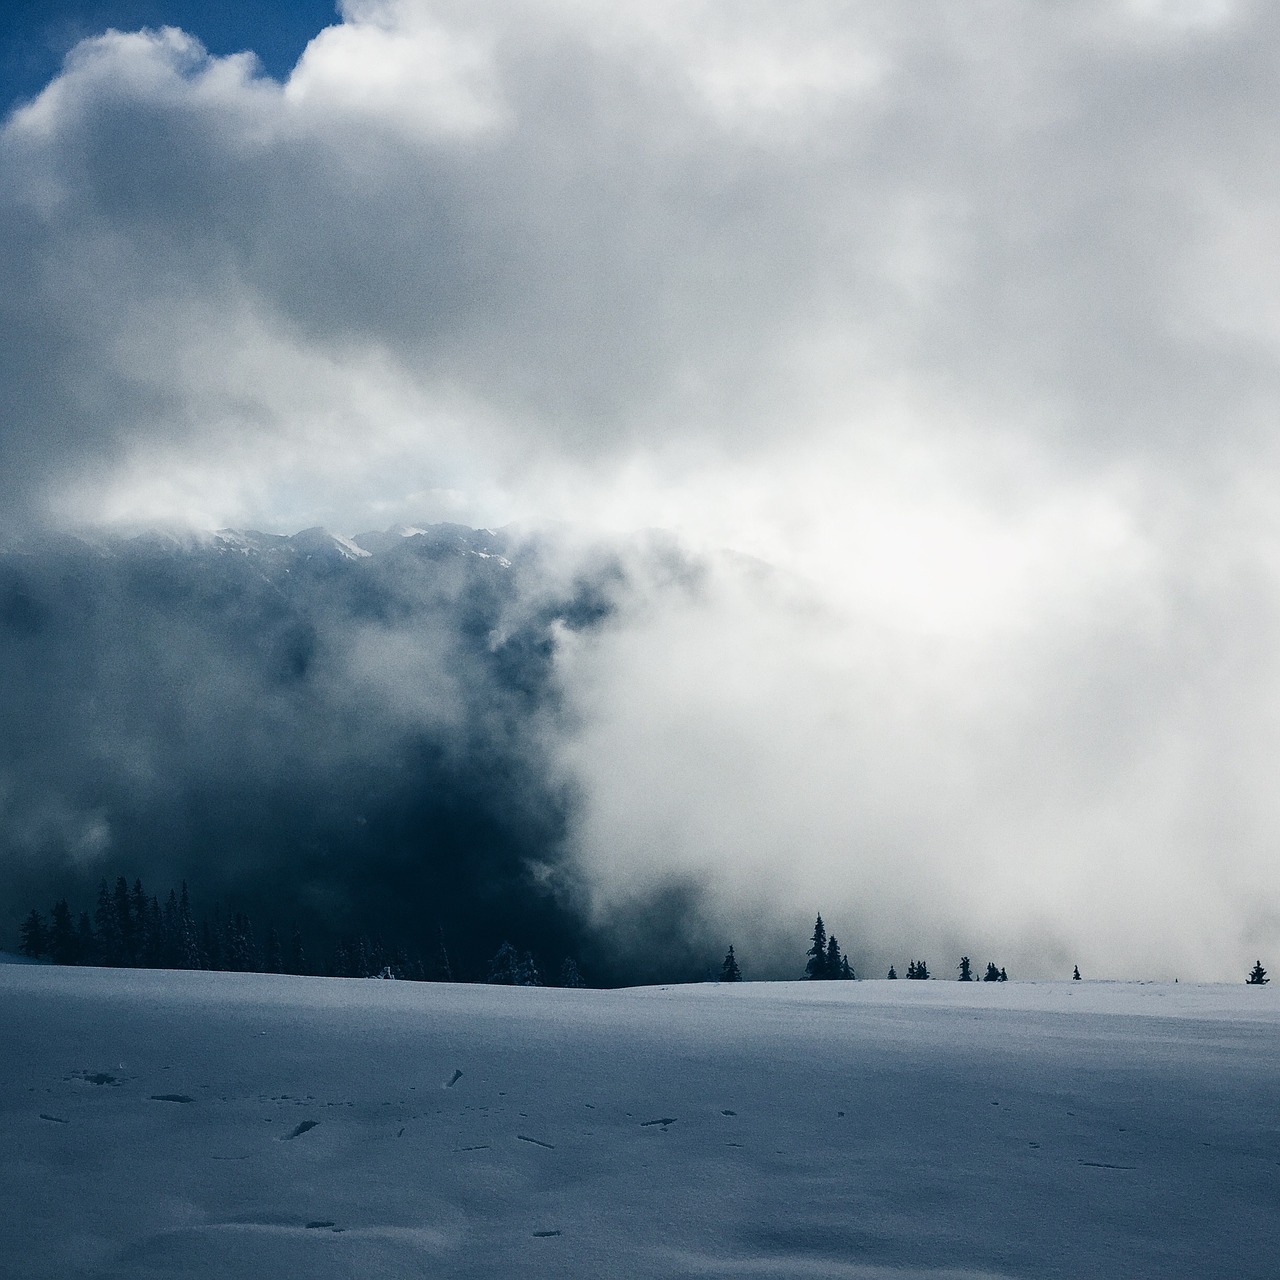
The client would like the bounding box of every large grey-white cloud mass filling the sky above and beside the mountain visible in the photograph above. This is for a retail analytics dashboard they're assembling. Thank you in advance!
[0,0,1280,977]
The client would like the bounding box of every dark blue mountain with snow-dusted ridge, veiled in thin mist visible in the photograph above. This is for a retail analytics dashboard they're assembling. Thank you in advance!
[0,525,714,982]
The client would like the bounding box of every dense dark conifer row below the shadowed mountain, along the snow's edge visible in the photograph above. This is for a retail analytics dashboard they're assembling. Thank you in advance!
[19,876,585,987]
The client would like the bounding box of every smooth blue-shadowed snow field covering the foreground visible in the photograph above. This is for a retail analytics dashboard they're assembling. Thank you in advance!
[0,965,1280,1280]
